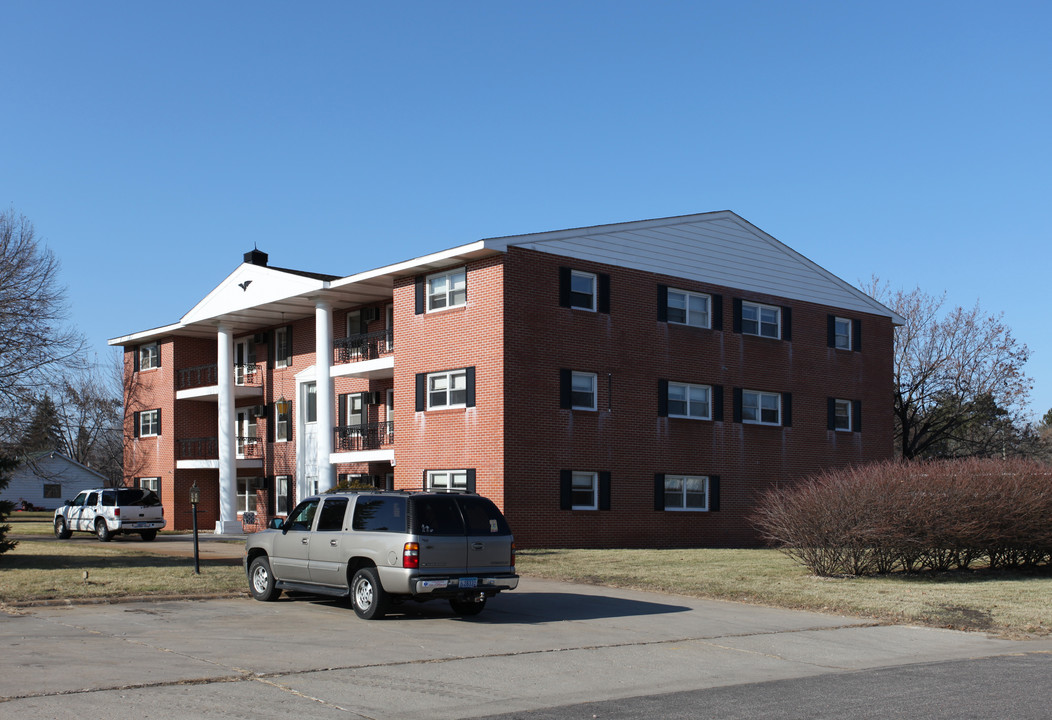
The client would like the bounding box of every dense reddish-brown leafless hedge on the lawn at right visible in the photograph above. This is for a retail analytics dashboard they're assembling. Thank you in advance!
[754,460,1052,576]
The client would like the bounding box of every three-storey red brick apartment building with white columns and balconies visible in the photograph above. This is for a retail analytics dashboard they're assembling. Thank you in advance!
[110,212,902,546]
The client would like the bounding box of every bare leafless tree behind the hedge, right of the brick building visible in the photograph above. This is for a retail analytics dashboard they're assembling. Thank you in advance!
[865,278,1032,459]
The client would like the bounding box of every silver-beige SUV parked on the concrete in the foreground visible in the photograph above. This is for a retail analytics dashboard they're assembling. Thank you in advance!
[244,491,519,620]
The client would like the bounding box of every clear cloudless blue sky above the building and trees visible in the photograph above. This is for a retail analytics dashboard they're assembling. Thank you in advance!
[0,0,1052,417]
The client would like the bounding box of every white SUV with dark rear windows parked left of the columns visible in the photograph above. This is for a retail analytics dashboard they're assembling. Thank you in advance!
[55,487,164,542]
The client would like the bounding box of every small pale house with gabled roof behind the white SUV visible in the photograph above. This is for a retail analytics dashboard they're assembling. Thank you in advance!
[0,452,107,509]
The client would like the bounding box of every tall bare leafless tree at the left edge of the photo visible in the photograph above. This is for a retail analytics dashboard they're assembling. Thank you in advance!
[0,211,84,438]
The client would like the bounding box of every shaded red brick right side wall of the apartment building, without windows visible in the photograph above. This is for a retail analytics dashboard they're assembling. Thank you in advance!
[496,248,892,546]
